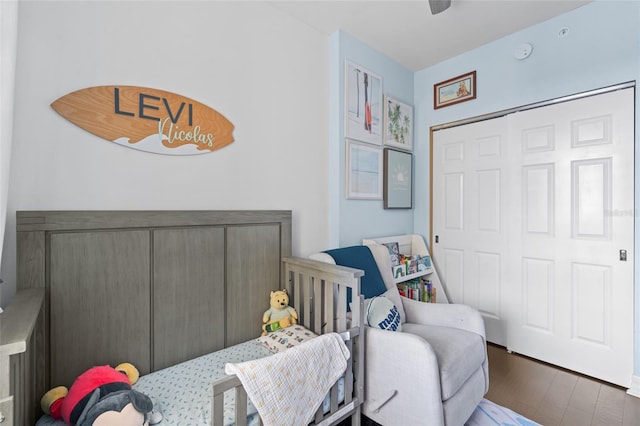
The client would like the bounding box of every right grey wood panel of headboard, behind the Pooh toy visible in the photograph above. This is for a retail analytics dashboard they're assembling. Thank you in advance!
[226,224,282,346]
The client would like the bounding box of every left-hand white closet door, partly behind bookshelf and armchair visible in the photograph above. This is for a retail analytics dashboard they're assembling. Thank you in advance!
[431,117,512,346]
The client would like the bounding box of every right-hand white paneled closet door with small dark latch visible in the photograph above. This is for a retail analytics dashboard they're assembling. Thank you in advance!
[508,89,635,387]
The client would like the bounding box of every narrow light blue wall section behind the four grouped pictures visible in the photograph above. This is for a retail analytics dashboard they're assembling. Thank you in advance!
[329,31,415,247]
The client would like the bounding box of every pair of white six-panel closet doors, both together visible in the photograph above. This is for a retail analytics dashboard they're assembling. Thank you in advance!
[432,89,634,387]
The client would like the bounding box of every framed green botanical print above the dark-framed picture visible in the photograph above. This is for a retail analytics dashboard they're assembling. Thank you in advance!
[384,95,413,151]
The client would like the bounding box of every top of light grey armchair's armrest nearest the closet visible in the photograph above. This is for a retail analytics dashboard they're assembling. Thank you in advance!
[402,297,485,339]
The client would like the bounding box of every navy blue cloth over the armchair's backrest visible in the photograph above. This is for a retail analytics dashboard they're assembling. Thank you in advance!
[325,246,387,303]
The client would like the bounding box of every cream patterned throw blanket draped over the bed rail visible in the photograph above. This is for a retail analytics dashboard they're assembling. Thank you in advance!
[225,333,350,426]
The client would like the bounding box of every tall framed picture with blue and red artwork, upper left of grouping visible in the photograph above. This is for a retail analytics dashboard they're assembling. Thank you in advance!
[344,61,383,145]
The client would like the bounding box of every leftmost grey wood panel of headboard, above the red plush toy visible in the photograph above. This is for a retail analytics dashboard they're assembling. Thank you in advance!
[49,231,151,387]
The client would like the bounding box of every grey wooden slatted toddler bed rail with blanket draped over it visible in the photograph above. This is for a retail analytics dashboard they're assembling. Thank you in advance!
[212,258,364,425]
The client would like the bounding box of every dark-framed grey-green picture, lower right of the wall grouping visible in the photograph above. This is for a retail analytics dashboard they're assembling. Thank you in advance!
[383,148,413,209]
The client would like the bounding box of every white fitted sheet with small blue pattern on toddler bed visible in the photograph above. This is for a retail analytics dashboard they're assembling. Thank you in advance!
[36,339,344,426]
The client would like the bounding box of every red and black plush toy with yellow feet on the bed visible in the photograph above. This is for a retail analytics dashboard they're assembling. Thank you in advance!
[40,363,162,426]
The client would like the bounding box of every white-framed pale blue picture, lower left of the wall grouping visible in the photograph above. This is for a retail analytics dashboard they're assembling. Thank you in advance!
[345,140,382,200]
